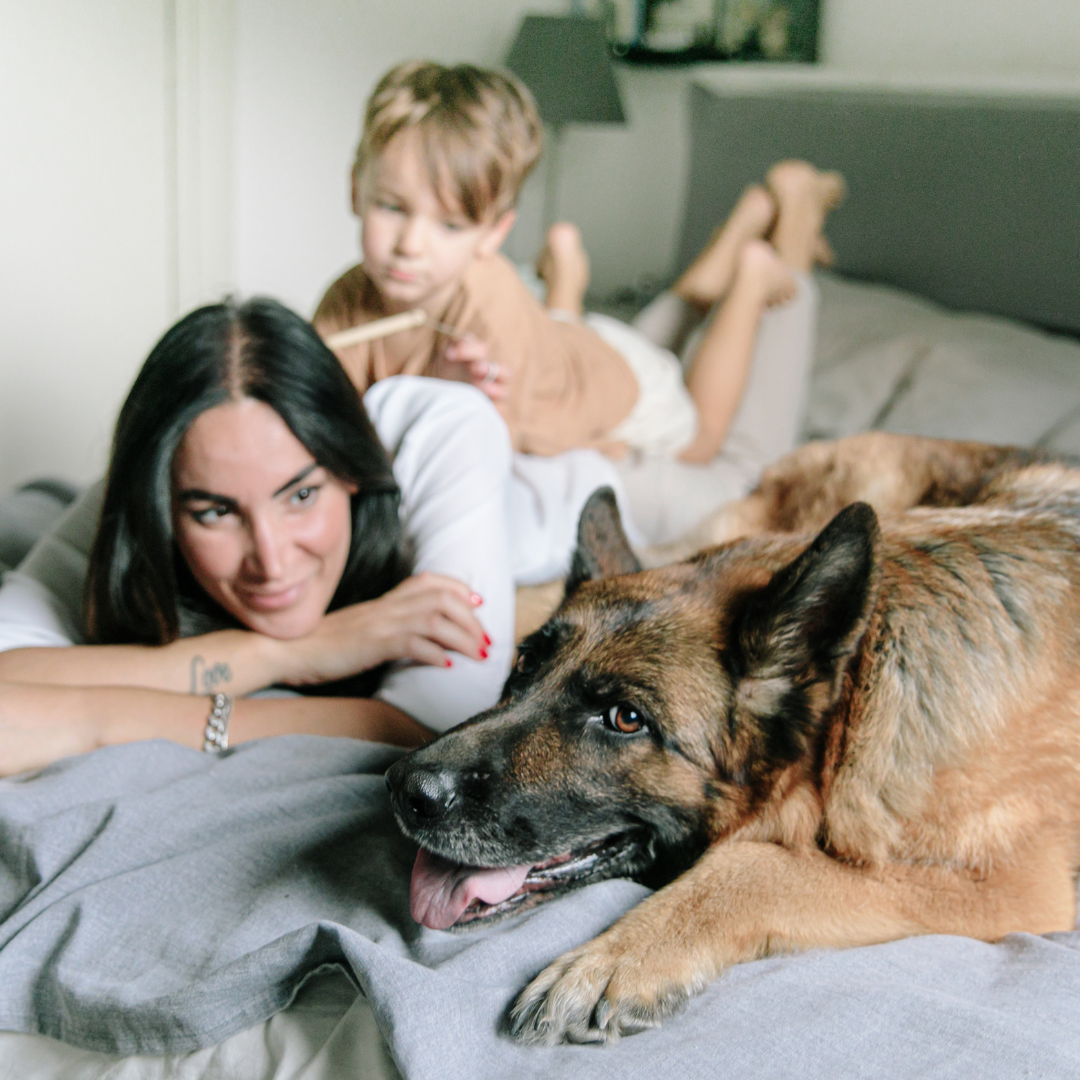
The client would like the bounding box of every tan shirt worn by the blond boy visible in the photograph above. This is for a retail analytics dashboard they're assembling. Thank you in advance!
[313,255,637,455]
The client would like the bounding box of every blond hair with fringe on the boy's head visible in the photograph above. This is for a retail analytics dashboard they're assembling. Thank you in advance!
[352,60,541,222]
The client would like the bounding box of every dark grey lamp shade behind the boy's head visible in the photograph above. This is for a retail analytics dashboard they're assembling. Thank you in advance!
[507,15,626,124]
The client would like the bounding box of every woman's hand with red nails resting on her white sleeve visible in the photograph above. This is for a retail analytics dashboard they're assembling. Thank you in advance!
[279,572,491,685]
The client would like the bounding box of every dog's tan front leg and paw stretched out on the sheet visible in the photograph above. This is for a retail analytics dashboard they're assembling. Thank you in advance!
[510,842,1076,1043]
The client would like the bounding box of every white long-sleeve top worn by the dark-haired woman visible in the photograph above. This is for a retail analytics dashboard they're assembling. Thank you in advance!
[0,376,636,731]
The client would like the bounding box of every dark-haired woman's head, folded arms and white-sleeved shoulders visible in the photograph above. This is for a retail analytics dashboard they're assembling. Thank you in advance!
[0,299,606,773]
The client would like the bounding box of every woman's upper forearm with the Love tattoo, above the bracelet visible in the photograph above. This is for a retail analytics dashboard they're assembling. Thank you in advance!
[0,630,292,694]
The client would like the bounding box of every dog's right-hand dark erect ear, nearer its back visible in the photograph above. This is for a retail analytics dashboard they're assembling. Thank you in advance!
[739,502,881,697]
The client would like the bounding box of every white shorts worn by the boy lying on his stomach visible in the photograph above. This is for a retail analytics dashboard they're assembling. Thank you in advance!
[584,314,698,458]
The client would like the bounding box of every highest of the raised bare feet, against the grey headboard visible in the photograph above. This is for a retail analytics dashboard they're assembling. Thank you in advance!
[766,161,847,271]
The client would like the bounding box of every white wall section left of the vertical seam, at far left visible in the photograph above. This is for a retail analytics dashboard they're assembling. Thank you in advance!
[0,0,167,487]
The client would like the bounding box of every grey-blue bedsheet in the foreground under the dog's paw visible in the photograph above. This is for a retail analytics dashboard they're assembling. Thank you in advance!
[0,737,1080,1080]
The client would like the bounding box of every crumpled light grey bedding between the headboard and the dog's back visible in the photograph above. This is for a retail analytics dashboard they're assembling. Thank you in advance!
[804,273,1080,454]
